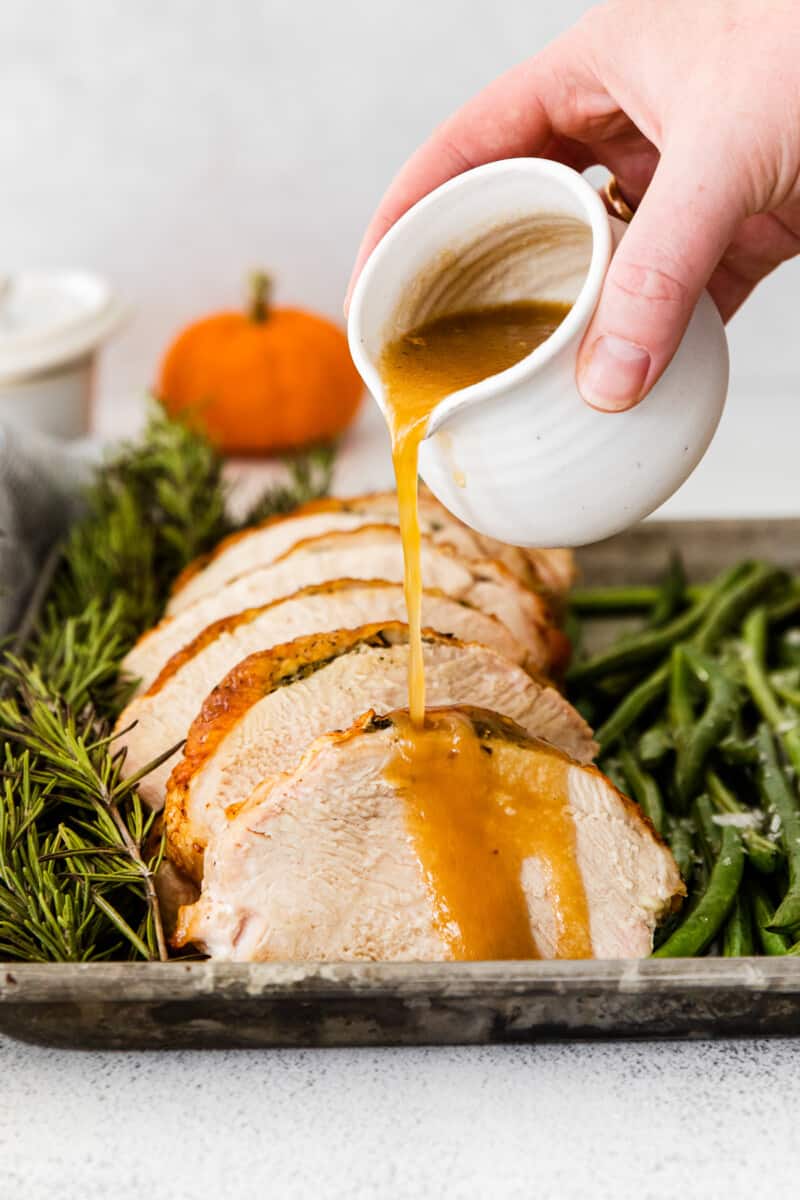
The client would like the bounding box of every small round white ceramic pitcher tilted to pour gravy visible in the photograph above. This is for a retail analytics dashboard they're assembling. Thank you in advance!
[349,158,728,546]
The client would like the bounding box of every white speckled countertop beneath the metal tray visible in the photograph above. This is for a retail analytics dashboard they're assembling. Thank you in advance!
[0,386,800,1200]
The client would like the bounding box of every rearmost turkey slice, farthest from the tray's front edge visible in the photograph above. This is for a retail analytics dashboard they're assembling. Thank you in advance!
[167,488,573,616]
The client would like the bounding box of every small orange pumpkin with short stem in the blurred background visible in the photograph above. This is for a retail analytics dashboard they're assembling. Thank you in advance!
[158,272,363,454]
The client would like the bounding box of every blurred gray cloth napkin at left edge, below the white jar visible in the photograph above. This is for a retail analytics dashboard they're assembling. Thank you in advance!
[0,425,101,635]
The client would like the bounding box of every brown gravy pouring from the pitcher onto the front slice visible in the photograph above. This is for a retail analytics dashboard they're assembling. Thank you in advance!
[380,301,591,960]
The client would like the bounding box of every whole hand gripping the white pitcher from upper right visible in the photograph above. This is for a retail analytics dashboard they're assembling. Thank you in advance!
[348,0,800,412]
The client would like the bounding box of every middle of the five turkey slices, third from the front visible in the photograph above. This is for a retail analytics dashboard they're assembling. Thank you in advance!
[116,580,527,809]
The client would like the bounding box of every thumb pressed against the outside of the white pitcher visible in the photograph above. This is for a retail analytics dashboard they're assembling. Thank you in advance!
[577,156,745,413]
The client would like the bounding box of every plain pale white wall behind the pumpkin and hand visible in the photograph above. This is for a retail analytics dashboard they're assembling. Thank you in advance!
[0,0,800,487]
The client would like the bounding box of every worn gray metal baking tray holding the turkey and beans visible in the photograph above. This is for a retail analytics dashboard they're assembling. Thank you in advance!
[0,520,800,1049]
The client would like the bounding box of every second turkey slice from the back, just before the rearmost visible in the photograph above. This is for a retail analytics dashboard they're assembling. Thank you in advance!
[122,526,567,690]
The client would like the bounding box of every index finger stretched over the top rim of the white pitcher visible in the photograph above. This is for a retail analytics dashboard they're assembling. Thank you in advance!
[344,35,597,312]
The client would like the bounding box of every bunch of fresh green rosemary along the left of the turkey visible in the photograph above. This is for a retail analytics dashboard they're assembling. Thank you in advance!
[0,409,332,962]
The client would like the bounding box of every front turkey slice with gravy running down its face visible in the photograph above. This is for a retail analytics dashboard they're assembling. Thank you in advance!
[176,709,685,961]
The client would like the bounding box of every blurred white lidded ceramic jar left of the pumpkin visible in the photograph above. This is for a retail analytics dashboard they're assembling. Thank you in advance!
[0,271,126,438]
